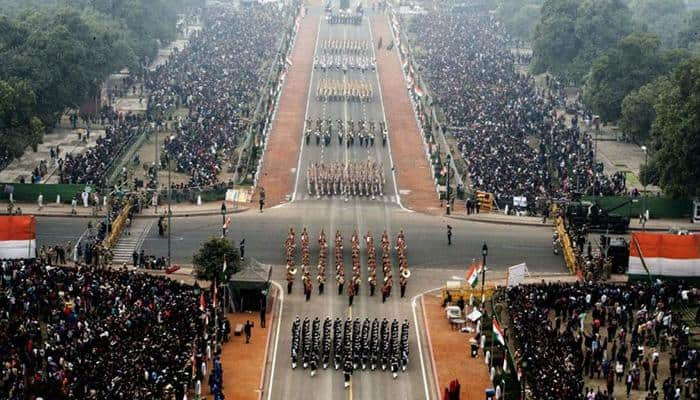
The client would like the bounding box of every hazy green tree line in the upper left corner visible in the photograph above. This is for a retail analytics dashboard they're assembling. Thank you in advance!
[0,0,203,165]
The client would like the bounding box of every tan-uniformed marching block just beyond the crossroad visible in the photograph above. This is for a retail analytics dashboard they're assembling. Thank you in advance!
[306,160,385,199]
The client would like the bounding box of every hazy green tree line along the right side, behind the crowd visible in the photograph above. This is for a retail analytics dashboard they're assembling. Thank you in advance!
[512,0,700,197]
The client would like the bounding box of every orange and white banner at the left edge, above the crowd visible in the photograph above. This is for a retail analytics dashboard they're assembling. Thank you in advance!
[0,215,36,260]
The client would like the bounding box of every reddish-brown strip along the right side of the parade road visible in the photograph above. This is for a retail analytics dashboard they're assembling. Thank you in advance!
[371,15,440,214]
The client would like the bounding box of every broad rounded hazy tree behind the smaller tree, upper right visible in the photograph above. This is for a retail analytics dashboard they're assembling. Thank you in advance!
[583,33,666,121]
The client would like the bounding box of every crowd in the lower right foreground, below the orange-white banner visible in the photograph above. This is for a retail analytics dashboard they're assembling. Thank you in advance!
[506,282,700,400]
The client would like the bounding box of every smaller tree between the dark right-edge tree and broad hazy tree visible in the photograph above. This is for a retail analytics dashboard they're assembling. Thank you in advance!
[618,76,670,144]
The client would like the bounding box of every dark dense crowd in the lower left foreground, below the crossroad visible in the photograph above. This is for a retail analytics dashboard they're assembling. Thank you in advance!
[0,260,217,400]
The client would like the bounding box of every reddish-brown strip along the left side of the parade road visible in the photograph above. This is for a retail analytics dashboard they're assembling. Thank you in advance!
[254,16,320,207]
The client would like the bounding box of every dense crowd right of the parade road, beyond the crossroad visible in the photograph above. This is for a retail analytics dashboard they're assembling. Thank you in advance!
[409,9,625,212]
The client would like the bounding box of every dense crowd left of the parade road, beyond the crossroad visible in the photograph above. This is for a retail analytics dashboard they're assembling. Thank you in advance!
[24,3,298,189]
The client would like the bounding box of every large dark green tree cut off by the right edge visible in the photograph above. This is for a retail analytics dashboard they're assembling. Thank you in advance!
[648,56,700,197]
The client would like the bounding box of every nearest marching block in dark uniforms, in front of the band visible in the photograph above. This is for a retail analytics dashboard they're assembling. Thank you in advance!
[290,316,409,387]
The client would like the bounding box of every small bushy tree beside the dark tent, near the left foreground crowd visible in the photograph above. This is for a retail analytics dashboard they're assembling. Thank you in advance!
[192,237,241,282]
